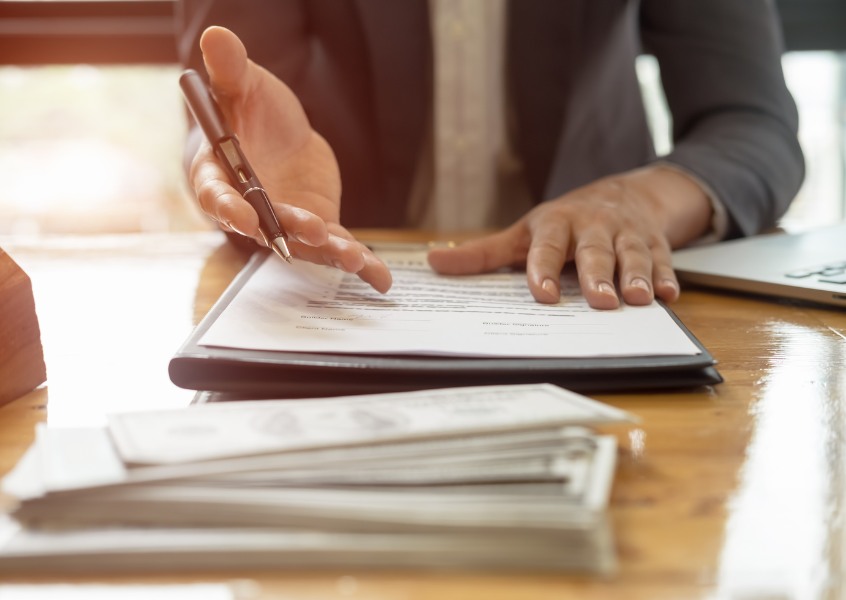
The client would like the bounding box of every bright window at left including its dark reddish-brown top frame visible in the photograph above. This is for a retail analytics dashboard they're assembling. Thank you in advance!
[0,0,209,233]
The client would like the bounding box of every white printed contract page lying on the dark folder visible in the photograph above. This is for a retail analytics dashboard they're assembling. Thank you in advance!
[199,247,701,358]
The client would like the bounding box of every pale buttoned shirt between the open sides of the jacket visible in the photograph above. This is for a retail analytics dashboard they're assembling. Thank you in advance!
[409,0,532,232]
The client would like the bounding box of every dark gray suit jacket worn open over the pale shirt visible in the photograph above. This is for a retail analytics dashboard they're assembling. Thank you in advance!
[179,0,804,236]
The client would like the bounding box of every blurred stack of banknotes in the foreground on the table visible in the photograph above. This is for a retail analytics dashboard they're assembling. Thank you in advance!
[0,384,633,572]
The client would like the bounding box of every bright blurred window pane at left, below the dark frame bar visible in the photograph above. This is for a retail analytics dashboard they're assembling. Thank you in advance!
[0,65,210,234]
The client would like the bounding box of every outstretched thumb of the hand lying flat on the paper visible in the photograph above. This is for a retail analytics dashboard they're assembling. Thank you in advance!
[428,229,528,275]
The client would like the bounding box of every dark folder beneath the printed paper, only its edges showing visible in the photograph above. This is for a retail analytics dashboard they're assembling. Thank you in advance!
[168,251,723,399]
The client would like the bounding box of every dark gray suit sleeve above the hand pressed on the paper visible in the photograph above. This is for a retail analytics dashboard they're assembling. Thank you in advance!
[641,0,805,237]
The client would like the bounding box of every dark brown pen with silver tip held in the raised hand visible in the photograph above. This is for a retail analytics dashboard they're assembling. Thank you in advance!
[179,69,293,262]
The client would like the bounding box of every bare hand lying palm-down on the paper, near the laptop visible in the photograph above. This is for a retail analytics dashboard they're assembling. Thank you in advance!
[429,166,712,309]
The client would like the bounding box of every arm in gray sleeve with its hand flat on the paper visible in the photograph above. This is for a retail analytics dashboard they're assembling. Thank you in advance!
[430,0,803,308]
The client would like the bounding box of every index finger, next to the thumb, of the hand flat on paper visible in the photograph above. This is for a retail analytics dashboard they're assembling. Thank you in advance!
[526,218,571,304]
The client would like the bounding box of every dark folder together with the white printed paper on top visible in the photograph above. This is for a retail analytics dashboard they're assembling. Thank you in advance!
[168,246,722,398]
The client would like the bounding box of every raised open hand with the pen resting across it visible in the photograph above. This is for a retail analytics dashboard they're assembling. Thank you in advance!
[190,27,391,293]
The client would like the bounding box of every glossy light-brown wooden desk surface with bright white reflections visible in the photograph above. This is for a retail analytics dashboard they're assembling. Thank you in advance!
[0,232,846,600]
